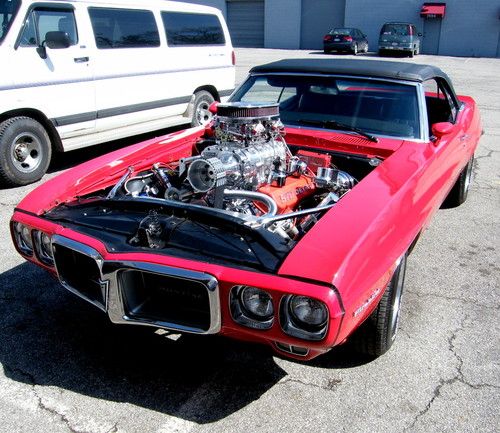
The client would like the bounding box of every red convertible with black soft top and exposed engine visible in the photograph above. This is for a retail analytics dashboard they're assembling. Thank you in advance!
[11,59,481,360]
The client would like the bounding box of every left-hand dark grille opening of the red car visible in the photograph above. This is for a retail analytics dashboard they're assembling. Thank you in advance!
[53,243,106,309]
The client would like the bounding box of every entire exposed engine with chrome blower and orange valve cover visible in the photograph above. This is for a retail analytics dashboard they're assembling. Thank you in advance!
[107,103,356,248]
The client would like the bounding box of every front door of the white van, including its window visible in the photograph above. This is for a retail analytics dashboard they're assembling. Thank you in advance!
[13,2,96,140]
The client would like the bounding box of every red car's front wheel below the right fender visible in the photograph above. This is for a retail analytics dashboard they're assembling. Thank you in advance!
[352,254,407,357]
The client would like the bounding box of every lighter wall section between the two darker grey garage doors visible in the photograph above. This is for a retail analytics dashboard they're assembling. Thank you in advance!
[264,0,302,49]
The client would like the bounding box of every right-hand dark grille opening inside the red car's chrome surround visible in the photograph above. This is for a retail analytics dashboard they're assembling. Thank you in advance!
[118,270,211,332]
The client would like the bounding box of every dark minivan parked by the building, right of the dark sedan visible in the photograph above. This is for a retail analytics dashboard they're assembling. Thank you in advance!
[378,23,422,57]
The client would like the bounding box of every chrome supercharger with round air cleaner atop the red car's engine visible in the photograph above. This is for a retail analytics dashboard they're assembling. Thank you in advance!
[187,104,291,192]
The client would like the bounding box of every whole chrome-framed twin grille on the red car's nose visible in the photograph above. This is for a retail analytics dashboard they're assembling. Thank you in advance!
[52,235,221,334]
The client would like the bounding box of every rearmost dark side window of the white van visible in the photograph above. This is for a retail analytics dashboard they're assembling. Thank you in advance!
[161,12,226,46]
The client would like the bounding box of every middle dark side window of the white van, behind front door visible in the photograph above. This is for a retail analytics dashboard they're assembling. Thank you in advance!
[89,7,160,49]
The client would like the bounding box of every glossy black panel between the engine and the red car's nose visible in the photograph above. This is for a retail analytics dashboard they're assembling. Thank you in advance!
[44,199,295,273]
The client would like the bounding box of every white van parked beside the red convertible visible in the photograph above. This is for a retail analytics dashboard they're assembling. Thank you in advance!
[0,0,235,185]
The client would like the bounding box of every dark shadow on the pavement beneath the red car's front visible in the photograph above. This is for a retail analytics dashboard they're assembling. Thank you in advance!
[0,263,376,424]
